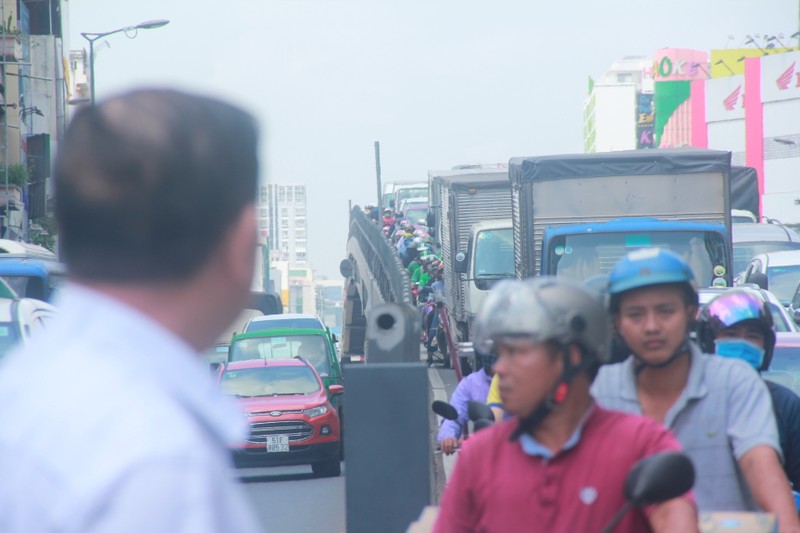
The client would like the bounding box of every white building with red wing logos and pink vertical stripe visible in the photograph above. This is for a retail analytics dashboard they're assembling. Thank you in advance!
[693,47,800,225]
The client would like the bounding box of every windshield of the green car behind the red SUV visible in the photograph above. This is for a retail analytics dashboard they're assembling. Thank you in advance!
[228,335,330,376]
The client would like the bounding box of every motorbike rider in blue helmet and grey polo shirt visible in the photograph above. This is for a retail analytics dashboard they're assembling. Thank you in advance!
[592,248,800,532]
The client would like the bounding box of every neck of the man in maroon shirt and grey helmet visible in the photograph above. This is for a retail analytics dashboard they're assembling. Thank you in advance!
[531,375,592,453]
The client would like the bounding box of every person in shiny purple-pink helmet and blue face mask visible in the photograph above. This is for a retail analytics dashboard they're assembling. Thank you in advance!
[696,288,800,491]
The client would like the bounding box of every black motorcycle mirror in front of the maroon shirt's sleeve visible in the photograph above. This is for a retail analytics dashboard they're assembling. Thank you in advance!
[602,452,695,533]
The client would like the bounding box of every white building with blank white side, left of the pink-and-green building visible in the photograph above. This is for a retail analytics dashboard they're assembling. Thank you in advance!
[583,56,653,153]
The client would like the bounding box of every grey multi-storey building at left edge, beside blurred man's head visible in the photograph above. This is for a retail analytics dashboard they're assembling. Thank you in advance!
[0,0,69,243]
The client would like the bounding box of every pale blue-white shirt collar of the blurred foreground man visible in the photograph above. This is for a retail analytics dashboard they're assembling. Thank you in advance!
[53,283,248,445]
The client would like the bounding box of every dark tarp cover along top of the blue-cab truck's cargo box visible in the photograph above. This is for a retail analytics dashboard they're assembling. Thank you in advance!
[508,148,731,185]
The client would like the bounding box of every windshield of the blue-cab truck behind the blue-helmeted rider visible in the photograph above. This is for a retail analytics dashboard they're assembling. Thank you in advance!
[546,231,727,287]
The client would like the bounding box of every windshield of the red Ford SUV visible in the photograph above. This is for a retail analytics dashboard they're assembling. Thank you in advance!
[220,366,320,398]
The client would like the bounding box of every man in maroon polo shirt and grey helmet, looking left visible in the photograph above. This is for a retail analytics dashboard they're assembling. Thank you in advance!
[435,278,697,533]
